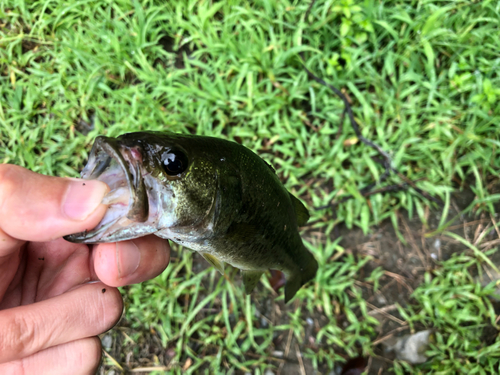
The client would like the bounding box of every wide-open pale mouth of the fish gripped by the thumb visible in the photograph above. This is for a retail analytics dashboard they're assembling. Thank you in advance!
[64,136,149,243]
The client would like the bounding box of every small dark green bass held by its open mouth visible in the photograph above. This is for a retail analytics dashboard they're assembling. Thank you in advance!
[64,131,318,303]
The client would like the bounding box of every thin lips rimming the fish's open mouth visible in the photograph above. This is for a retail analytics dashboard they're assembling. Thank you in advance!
[64,136,149,243]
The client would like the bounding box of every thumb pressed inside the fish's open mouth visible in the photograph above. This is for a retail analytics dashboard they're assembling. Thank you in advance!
[0,164,109,250]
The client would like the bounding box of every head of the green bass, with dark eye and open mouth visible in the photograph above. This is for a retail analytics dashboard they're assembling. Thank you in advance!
[65,132,217,243]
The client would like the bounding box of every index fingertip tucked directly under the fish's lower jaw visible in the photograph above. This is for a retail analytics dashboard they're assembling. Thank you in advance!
[93,235,170,286]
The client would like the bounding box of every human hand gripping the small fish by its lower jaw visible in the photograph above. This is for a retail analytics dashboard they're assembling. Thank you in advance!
[0,164,170,374]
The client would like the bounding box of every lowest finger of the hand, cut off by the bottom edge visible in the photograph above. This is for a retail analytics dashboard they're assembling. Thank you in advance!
[0,337,101,375]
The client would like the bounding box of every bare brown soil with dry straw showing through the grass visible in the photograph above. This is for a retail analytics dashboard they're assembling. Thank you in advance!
[95,186,500,375]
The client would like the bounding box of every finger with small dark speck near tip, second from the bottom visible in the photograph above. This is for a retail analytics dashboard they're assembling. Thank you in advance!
[0,283,123,363]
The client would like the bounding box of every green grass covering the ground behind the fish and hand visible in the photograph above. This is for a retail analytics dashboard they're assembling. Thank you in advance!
[0,0,500,374]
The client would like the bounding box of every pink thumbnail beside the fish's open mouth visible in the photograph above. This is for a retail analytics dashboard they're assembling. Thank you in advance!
[63,178,109,220]
